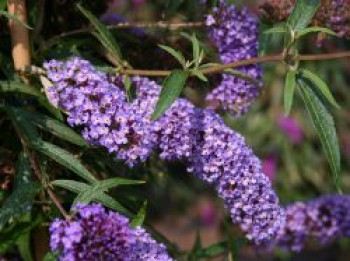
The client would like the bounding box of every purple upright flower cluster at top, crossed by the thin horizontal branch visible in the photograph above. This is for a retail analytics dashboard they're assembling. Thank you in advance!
[206,1,262,116]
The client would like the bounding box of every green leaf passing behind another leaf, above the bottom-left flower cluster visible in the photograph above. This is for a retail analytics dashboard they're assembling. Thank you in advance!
[51,180,131,216]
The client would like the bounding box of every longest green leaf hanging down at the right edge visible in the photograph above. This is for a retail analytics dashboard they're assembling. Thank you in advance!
[298,78,341,190]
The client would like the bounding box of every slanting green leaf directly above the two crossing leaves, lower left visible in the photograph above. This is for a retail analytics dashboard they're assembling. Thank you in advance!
[35,141,97,183]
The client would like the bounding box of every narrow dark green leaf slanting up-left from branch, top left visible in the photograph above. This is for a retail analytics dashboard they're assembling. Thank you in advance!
[77,4,123,65]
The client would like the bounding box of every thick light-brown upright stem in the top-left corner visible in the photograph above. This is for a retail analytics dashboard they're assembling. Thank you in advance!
[7,0,30,80]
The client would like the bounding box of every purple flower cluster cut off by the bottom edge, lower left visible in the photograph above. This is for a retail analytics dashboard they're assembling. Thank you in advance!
[50,203,173,261]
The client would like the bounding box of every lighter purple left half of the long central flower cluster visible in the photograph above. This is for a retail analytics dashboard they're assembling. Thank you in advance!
[44,57,159,166]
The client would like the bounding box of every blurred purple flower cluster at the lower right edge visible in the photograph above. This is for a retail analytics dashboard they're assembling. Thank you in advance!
[275,195,350,252]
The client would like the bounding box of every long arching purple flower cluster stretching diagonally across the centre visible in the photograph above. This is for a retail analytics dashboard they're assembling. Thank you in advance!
[45,58,284,244]
